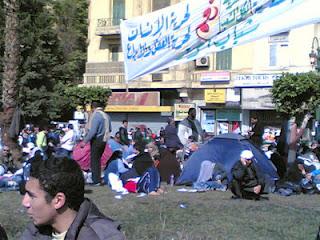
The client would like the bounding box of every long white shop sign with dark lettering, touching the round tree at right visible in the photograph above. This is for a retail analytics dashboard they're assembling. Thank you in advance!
[234,74,281,87]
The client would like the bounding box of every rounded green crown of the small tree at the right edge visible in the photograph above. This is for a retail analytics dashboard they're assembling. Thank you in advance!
[271,72,320,116]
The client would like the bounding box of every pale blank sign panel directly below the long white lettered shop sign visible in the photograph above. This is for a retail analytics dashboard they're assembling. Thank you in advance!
[241,88,275,110]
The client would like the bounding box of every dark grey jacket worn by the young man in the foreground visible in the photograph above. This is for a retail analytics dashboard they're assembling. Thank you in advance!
[20,199,125,240]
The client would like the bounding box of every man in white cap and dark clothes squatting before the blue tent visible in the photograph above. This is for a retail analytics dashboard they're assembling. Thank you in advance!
[231,150,264,200]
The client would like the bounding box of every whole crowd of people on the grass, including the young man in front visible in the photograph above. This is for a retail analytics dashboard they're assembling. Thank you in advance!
[0,102,320,239]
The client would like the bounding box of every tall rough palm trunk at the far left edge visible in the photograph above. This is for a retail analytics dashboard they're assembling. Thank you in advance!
[1,0,21,160]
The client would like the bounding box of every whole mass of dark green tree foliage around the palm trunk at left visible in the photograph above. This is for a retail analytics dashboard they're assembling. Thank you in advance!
[0,0,95,121]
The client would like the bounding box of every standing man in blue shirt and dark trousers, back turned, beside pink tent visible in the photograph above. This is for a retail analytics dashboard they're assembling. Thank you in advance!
[81,102,111,185]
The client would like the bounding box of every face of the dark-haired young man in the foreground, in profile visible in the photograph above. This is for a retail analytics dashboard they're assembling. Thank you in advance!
[22,177,57,226]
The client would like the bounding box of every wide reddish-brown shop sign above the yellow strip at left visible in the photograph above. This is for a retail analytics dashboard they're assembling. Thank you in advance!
[108,92,160,106]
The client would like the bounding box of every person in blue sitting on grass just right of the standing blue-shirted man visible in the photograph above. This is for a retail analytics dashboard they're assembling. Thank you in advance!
[103,150,129,187]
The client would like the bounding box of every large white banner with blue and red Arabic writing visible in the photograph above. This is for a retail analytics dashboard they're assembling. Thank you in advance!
[120,0,320,80]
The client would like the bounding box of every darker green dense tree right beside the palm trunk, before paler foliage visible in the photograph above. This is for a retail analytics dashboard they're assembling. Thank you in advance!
[18,0,64,122]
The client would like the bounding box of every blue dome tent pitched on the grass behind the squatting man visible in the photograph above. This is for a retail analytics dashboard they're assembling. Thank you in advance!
[177,133,279,184]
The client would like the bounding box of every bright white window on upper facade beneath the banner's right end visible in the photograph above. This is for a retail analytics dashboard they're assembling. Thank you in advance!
[269,32,289,67]
